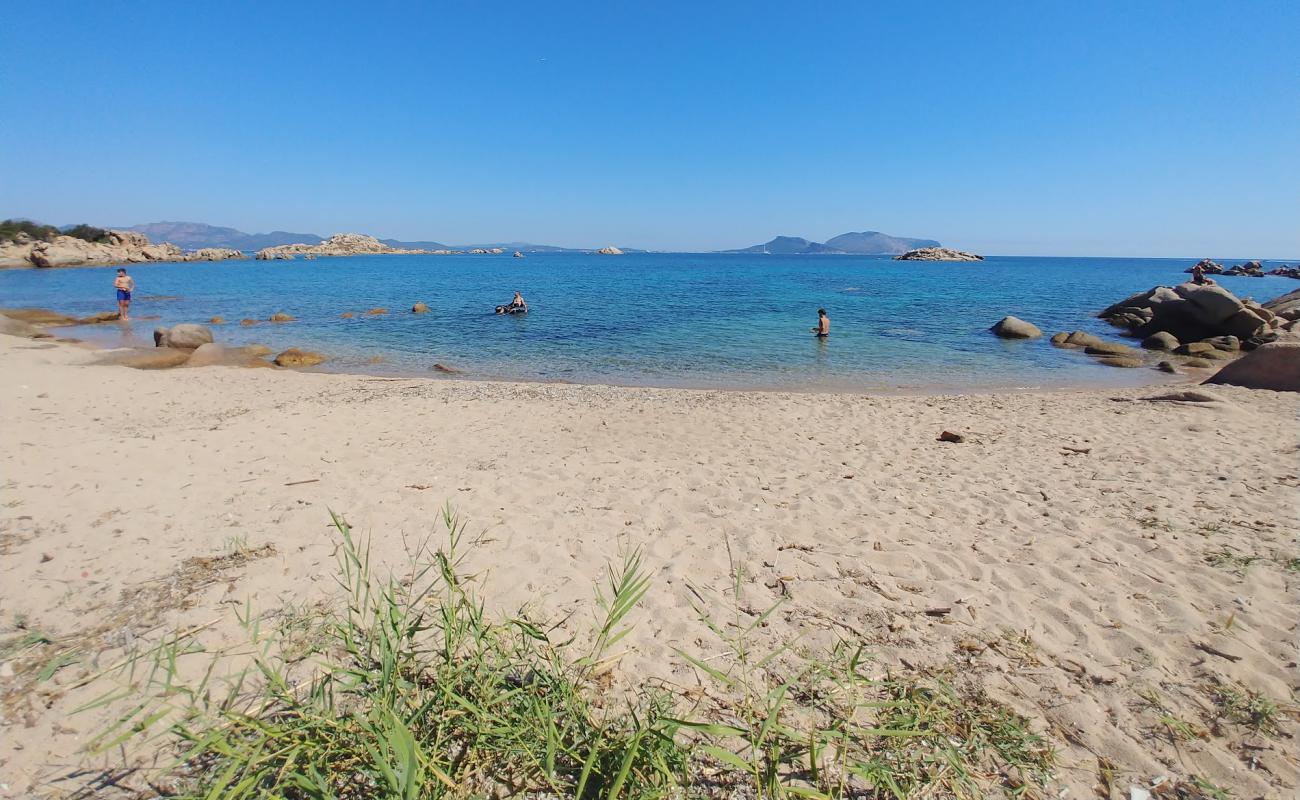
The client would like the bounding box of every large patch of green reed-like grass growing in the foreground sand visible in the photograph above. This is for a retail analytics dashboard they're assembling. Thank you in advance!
[86,510,1053,800]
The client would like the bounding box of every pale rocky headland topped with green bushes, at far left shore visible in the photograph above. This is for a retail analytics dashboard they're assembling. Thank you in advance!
[0,230,246,269]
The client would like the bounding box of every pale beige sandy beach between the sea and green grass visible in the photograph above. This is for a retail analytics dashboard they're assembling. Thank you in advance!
[0,337,1300,799]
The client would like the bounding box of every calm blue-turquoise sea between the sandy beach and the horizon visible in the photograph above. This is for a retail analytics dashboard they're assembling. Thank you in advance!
[0,254,1300,390]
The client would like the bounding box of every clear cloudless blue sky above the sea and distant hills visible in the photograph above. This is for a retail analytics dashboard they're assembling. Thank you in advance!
[0,0,1300,258]
